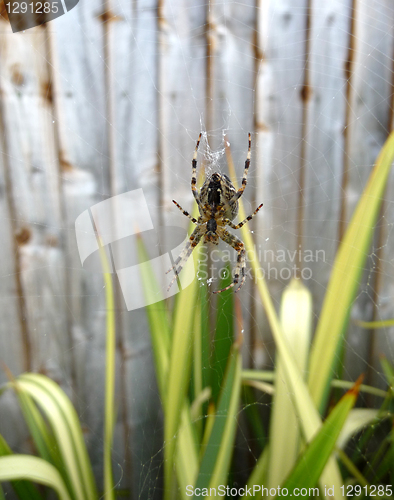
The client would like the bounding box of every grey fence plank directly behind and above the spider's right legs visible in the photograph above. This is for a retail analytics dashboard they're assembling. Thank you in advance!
[207,0,257,348]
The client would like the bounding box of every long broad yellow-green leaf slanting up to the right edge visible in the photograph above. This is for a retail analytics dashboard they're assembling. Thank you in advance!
[309,132,394,411]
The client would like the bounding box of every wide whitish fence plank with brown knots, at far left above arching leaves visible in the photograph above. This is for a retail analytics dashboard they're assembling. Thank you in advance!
[1,28,69,382]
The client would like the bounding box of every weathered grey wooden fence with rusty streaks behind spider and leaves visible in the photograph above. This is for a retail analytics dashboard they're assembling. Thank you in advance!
[0,0,394,498]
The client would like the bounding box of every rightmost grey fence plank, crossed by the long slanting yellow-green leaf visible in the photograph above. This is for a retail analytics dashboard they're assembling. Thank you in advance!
[343,1,394,387]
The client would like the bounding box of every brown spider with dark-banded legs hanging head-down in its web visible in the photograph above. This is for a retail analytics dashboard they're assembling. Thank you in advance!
[167,134,263,293]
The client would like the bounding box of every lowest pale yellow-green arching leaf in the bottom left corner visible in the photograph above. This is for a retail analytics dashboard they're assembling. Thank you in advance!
[0,455,71,500]
